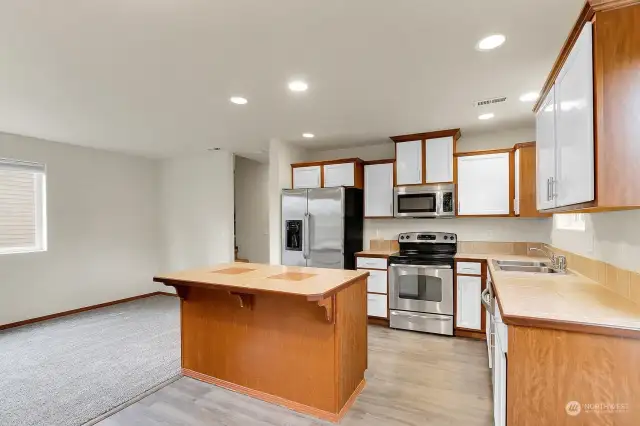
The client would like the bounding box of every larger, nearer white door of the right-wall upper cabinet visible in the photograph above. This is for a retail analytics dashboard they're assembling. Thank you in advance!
[553,22,606,207]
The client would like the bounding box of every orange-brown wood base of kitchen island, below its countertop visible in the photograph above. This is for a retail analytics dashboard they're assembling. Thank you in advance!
[173,276,367,422]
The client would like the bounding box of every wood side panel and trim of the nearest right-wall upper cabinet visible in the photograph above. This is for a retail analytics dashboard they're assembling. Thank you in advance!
[533,0,640,214]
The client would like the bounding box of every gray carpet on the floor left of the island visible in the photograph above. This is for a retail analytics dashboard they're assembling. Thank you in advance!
[0,296,180,426]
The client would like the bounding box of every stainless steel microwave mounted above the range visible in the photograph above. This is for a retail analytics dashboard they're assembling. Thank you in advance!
[393,184,456,218]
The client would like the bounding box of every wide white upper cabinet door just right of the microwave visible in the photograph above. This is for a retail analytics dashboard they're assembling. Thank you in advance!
[458,152,511,216]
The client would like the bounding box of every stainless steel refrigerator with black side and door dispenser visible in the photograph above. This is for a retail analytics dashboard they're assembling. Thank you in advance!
[282,187,364,269]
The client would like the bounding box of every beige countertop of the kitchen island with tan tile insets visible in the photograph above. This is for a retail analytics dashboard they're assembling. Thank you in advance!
[153,262,369,300]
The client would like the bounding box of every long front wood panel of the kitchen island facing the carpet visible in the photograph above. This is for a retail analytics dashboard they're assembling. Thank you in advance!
[182,288,338,412]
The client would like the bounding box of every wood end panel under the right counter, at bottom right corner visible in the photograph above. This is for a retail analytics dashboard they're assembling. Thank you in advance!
[507,326,640,426]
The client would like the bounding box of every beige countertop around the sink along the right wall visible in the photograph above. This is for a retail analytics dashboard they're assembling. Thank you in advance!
[456,253,640,338]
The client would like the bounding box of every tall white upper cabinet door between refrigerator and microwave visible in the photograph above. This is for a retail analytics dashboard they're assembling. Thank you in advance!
[364,163,393,217]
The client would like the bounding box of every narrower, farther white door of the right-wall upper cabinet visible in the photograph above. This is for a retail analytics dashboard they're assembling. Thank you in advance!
[536,88,556,210]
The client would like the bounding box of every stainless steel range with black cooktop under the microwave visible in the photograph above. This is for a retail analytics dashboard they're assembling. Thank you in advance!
[389,232,458,336]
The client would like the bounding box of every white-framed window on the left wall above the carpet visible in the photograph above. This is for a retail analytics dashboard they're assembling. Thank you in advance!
[0,158,47,255]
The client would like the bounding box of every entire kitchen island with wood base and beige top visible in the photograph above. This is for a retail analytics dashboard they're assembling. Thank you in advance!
[154,263,369,422]
